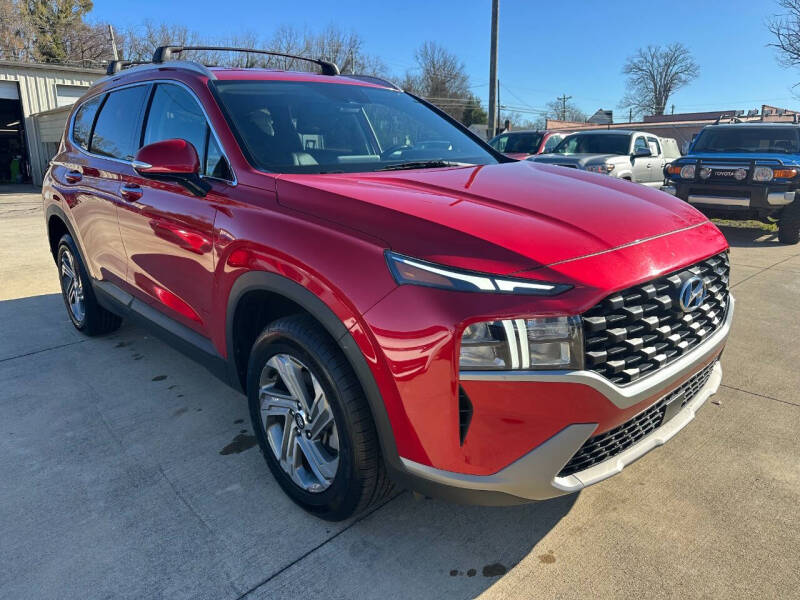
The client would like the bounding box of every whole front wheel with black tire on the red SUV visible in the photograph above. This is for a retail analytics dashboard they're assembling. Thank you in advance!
[247,315,392,521]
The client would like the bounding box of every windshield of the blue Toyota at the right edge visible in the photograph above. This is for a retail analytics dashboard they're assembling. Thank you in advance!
[692,125,800,154]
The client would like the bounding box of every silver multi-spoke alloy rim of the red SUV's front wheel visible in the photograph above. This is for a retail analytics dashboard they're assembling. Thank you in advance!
[259,354,339,493]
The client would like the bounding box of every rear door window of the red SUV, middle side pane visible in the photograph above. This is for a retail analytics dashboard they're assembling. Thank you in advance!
[89,85,149,160]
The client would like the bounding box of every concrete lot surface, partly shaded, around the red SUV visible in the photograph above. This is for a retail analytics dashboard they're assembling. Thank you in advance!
[0,189,800,600]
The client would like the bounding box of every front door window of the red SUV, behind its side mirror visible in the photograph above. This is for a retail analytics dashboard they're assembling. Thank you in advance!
[144,83,232,180]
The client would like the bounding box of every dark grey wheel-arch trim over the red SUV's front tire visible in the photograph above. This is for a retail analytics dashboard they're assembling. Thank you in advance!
[225,271,405,473]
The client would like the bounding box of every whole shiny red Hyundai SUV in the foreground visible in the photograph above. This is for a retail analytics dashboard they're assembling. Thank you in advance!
[43,47,733,519]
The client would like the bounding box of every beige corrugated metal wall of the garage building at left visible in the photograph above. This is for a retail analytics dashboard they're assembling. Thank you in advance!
[0,62,103,185]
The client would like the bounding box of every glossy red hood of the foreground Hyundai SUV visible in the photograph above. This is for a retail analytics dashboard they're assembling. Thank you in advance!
[277,161,707,274]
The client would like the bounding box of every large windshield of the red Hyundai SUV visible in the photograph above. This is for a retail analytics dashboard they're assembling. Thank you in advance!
[213,81,497,173]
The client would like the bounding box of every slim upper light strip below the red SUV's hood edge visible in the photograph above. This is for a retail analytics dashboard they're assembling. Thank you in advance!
[386,250,572,296]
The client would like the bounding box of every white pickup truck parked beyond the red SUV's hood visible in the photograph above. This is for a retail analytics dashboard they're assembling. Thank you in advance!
[528,129,680,187]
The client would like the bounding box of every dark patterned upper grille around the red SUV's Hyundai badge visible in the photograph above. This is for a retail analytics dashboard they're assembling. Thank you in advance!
[583,252,730,385]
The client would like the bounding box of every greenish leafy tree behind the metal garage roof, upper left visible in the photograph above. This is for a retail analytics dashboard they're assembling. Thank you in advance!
[24,0,93,63]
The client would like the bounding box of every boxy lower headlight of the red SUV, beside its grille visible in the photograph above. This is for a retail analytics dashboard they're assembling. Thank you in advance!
[459,317,583,371]
